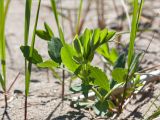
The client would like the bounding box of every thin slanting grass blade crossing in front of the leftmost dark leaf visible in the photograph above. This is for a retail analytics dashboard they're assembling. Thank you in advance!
[25,0,41,96]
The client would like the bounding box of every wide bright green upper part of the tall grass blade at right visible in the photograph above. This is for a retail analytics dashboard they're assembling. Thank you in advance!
[128,0,143,68]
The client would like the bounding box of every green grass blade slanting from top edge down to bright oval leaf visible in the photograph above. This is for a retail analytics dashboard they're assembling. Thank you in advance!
[50,0,65,45]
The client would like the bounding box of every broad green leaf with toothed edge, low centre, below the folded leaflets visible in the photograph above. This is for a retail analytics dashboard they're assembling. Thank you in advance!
[89,66,110,91]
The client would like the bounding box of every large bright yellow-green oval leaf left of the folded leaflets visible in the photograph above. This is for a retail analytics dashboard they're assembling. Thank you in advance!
[61,44,79,73]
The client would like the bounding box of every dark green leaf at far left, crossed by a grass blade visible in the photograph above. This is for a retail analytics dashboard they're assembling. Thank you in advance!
[20,46,43,64]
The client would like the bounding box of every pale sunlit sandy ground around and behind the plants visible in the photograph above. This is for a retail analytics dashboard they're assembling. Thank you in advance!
[0,0,160,120]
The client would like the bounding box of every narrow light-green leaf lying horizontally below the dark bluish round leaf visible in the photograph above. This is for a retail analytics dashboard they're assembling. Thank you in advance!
[37,60,59,68]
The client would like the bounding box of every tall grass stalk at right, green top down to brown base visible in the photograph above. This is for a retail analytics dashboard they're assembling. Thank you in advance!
[120,0,144,111]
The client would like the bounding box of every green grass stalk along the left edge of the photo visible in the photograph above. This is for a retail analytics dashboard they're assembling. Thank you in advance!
[0,0,10,114]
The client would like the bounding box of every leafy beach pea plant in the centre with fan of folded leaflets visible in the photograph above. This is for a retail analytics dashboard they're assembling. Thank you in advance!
[37,24,119,113]
